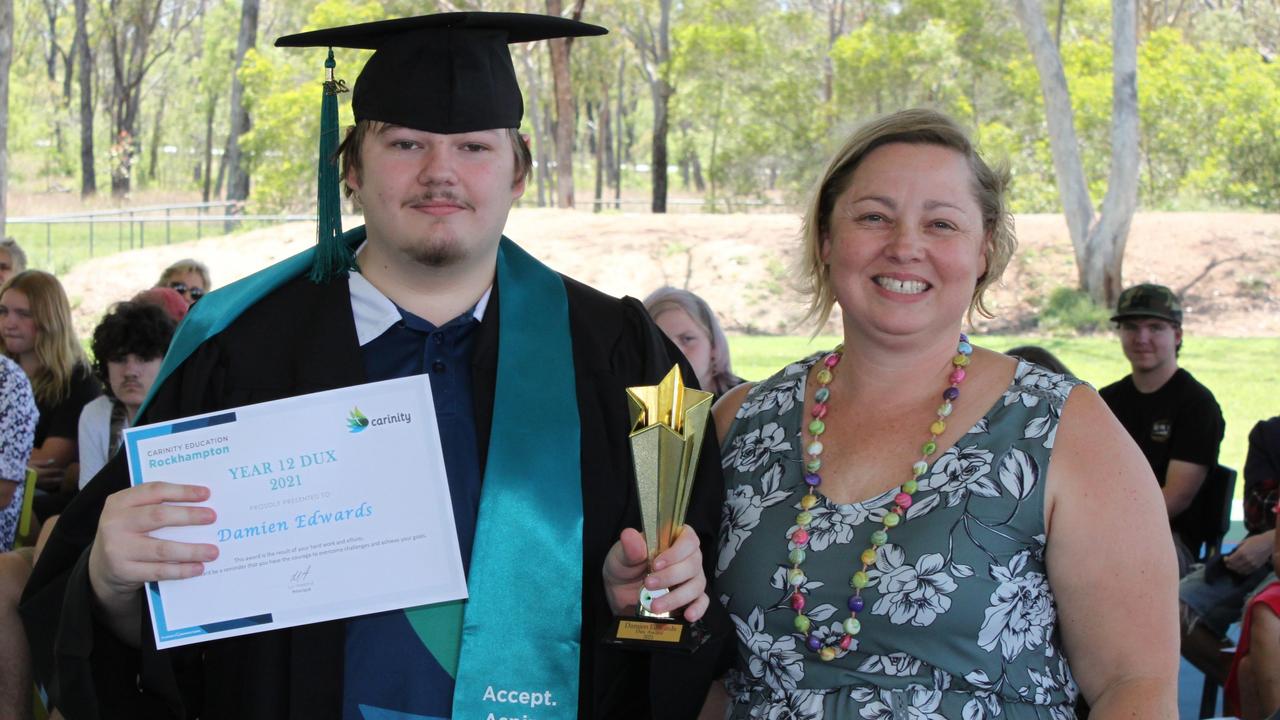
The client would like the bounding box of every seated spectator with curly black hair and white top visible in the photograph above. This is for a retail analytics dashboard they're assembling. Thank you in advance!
[79,301,174,488]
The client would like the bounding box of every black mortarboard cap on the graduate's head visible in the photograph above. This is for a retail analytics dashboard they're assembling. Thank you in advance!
[275,13,608,133]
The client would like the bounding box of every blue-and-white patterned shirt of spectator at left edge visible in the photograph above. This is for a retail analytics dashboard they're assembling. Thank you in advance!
[0,355,37,548]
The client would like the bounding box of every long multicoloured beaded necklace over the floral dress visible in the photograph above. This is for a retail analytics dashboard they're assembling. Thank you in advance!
[787,333,973,661]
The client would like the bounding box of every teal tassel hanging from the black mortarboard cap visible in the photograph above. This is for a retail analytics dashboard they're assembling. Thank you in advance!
[310,47,356,283]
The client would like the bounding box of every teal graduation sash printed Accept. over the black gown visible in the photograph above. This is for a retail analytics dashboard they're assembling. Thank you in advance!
[140,227,582,720]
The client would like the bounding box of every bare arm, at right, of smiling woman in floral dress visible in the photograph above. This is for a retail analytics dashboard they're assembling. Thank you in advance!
[1044,386,1179,720]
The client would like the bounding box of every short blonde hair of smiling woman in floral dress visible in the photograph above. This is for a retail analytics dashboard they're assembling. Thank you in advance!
[796,108,1018,327]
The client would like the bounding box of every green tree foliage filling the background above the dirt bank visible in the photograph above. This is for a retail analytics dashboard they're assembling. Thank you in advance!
[8,0,1280,213]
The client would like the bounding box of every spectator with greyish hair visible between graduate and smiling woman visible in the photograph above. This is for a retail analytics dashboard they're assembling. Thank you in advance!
[644,287,742,400]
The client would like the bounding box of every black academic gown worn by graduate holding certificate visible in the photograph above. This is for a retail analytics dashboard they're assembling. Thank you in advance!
[20,270,732,720]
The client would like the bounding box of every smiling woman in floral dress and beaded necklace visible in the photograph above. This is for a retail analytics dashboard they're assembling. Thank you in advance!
[714,110,1178,720]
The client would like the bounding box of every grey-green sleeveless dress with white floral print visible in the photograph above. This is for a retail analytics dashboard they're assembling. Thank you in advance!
[713,354,1079,720]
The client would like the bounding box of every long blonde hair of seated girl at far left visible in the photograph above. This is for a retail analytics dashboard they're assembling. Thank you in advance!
[0,270,87,407]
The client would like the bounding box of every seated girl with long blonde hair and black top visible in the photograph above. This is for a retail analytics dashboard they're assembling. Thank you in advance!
[0,270,102,499]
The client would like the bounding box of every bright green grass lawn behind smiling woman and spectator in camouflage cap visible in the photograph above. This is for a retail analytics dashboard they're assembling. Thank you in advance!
[730,336,1280,479]
